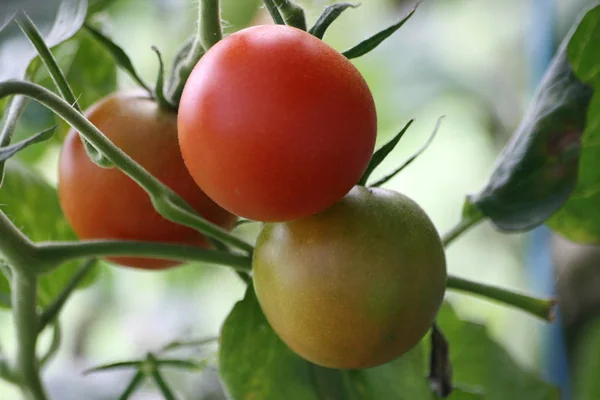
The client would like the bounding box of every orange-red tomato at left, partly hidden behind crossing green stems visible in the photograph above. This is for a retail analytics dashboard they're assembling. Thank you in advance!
[58,93,237,269]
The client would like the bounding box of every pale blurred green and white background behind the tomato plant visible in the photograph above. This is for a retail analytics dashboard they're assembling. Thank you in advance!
[0,0,586,400]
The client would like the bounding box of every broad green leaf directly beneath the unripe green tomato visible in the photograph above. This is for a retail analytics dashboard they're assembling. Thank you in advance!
[219,287,434,400]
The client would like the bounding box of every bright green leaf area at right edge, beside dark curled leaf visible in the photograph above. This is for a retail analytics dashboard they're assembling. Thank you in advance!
[548,6,600,243]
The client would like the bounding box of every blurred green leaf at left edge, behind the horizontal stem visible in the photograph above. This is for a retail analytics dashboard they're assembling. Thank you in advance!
[0,160,95,306]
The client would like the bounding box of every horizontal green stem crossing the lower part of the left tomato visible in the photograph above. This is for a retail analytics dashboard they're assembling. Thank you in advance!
[38,240,251,272]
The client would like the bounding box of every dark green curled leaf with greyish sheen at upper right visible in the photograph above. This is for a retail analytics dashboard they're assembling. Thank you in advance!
[467,18,600,232]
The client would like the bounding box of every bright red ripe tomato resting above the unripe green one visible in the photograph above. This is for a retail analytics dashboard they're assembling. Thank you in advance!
[178,25,377,222]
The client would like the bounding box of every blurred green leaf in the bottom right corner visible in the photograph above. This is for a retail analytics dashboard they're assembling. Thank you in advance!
[573,317,600,400]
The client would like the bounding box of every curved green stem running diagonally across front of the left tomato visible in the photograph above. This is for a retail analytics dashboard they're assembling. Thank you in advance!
[0,81,253,252]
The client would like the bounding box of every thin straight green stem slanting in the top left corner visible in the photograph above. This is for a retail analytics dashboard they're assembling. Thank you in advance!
[15,11,81,112]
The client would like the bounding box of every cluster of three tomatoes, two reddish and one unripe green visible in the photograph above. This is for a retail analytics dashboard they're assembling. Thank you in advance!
[59,25,446,368]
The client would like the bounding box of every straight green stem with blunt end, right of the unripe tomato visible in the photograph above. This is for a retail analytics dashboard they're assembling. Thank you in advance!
[447,276,556,321]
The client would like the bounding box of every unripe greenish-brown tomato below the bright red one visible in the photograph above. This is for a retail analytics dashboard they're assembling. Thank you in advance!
[253,187,446,369]
